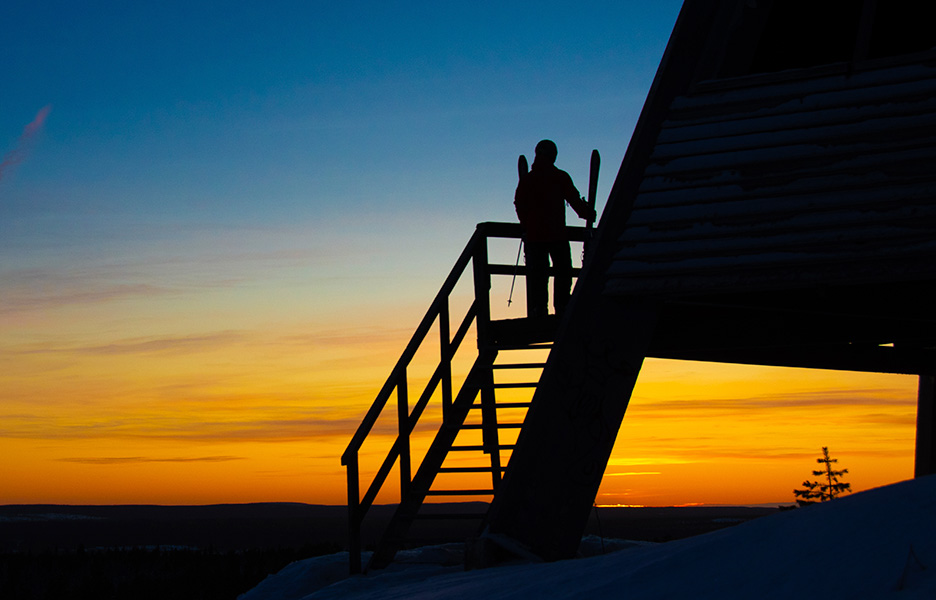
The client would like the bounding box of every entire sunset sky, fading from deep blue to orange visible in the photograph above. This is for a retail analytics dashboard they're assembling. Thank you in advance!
[0,0,917,505]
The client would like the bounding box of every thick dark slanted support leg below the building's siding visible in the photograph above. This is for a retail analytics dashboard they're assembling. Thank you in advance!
[477,298,657,564]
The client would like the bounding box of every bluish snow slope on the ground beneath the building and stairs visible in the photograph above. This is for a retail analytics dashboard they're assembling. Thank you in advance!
[240,476,936,600]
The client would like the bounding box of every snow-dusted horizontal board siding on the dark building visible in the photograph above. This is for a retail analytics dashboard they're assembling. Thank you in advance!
[606,56,936,296]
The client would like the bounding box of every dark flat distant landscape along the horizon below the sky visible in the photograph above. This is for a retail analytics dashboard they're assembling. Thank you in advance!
[0,503,776,600]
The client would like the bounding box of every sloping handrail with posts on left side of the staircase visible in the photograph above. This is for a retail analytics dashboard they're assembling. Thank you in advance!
[341,222,586,573]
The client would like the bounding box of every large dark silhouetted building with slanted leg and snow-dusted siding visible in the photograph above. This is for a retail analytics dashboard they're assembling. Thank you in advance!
[349,0,936,566]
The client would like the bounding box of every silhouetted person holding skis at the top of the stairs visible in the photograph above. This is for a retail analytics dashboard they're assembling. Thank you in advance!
[514,140,594,317]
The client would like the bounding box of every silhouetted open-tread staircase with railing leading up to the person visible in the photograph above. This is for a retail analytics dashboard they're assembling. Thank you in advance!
[341,223,585,573]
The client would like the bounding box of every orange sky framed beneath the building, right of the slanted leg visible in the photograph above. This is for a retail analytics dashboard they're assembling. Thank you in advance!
[598,360,917,506]
